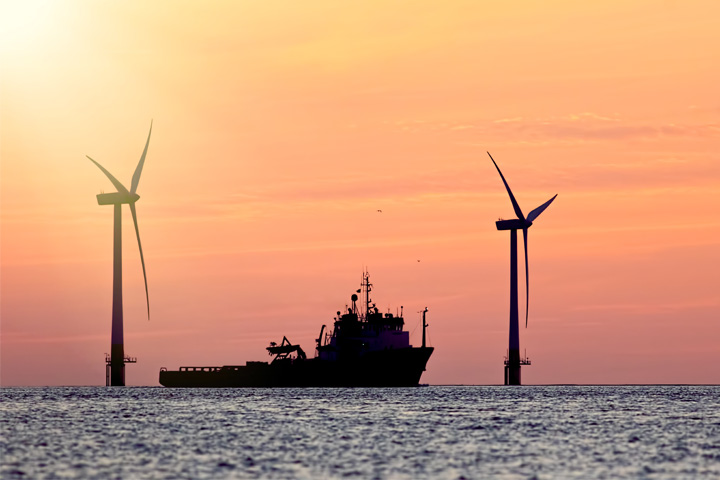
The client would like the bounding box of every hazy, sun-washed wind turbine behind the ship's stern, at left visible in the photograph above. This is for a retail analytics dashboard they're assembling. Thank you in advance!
[87,121,152,387]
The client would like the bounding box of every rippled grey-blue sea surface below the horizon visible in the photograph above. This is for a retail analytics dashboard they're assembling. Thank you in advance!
[0,386,720,479]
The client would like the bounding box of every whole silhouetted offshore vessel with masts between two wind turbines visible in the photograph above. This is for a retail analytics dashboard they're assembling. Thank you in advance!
[160,272,433,387]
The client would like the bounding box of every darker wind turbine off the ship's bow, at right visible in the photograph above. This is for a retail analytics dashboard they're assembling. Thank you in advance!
[487,152,557,385]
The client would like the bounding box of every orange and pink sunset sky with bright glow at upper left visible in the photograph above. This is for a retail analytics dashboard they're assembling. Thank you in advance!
[0,0,720,386]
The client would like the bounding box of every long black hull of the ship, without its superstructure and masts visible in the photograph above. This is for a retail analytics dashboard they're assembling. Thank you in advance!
[160,347,433,388]
